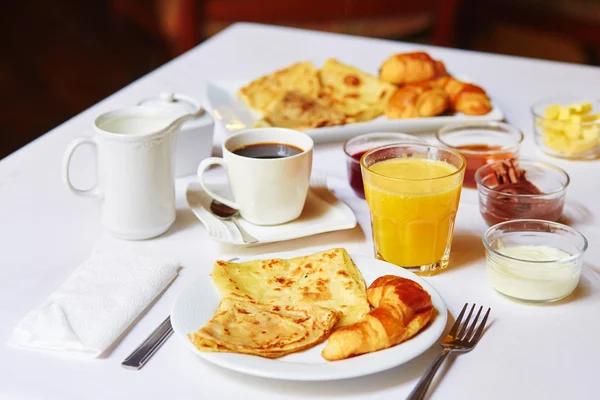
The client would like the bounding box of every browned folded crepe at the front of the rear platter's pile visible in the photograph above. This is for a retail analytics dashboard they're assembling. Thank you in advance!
[255,91,346,130]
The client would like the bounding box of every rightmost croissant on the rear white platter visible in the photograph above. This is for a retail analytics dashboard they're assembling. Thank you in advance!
[435,76,492,115]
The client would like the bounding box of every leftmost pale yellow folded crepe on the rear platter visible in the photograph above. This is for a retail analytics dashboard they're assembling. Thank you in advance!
[238,62,321,114]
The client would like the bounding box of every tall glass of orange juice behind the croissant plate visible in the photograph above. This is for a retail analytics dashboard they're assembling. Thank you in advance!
[360,142,466,275]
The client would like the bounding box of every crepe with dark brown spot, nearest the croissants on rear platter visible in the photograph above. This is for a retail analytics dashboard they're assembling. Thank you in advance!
[319,58,396,122]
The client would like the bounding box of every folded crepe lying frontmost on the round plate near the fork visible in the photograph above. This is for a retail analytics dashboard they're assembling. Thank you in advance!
[188,296,339,358]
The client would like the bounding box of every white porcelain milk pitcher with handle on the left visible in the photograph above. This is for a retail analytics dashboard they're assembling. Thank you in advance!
[62,106,201,240]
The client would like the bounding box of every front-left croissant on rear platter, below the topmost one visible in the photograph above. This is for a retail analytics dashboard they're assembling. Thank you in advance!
[385,82,450,119]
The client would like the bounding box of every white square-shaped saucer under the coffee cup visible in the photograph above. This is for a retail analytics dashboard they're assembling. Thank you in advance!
[186,177,356,246]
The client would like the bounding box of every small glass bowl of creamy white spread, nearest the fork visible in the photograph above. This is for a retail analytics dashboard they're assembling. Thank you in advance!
[482,219,588,302]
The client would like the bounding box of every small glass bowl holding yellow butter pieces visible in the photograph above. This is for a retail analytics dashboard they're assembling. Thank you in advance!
[531,96,600,160]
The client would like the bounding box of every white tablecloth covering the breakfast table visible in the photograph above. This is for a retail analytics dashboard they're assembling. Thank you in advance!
[0,24,600,400]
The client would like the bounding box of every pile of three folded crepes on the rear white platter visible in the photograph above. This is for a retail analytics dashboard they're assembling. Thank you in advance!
[238,59,396,129]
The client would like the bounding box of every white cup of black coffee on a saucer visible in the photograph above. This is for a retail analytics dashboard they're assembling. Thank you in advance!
[198,128,314,225]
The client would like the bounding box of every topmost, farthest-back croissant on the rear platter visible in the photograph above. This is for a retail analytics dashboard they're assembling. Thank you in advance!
[379,51,446,85]
